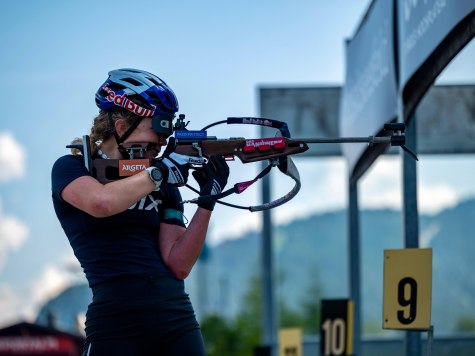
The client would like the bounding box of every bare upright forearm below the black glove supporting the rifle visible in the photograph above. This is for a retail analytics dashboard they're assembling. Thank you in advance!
[160,208,211,279]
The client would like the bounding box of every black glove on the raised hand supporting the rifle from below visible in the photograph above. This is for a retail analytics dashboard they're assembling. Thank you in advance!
[193,156,229,211]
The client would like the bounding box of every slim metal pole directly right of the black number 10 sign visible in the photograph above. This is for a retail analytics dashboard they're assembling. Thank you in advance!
[348,179,361,356]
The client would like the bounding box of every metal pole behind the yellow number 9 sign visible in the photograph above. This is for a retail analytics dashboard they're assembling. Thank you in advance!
[402,115,421,356]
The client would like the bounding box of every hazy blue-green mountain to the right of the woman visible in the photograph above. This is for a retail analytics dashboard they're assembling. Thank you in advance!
[187,199,475,333]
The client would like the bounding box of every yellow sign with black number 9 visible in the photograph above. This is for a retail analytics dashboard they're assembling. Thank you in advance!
[383,248,432,330]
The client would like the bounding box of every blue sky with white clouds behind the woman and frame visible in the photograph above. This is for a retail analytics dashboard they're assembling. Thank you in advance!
[0,0,475,327]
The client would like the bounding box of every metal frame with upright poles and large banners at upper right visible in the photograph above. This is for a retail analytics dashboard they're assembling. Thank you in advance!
[261,0,475,356]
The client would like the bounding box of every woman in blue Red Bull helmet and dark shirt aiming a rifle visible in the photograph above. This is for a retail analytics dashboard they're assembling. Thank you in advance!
[52,69,229,356]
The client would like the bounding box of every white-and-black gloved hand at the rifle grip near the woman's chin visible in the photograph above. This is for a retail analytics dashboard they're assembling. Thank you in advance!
[154,137,193,187]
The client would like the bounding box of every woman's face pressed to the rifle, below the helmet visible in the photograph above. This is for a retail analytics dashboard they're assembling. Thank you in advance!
[123,118,167,158]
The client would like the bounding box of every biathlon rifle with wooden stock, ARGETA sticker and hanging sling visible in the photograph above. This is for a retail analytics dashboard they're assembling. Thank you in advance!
[67,114,417,212]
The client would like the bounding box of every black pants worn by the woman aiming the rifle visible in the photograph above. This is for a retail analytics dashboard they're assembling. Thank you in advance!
[83,277,205,356]
